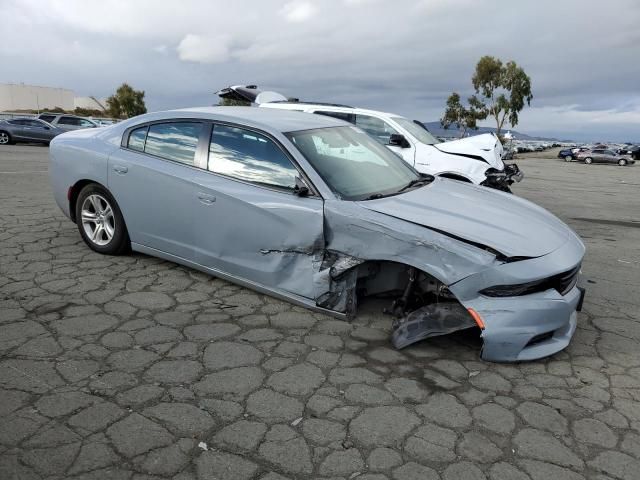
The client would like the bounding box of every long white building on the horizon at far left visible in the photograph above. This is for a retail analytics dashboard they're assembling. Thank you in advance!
[0,83,106,112]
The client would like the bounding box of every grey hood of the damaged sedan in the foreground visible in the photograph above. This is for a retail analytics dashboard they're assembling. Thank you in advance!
[358,178,580,257]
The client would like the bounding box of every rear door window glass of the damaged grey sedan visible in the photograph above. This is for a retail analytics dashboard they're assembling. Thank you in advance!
[144,122,202,165]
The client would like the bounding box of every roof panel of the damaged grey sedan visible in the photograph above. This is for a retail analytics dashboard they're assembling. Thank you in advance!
[129,107,349,133]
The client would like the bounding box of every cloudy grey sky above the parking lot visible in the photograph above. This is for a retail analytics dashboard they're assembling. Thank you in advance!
[0,0,640,141]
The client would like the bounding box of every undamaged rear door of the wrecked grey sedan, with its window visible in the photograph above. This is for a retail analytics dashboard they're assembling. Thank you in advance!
[109,119,206,261]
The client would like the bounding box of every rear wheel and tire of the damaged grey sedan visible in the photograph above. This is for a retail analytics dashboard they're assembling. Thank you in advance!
[75,183,131,255]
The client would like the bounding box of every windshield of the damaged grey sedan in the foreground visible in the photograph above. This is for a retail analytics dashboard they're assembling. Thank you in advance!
[287,127,421,200]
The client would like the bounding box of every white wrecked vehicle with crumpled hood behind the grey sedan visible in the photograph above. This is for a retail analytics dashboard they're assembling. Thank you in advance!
[217,85,523,191]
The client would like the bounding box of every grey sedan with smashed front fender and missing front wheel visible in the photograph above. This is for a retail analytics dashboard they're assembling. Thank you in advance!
[50,107,585,361]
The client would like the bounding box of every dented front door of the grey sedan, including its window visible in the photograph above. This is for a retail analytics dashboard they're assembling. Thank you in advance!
[193,124,324,298]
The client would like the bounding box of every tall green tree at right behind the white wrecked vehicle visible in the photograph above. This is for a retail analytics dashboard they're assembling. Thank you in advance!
[442,55,533,136]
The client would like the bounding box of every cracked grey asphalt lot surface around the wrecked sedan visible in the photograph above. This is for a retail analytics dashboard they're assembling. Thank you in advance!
[0,145,640,480]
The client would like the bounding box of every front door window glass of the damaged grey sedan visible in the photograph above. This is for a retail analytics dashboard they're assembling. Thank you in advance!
[208,125,298,189]
